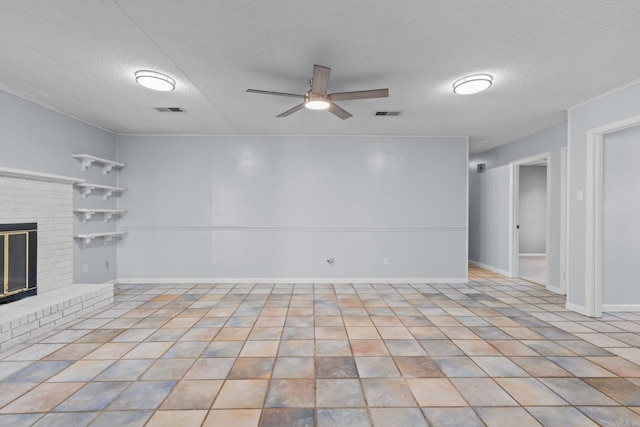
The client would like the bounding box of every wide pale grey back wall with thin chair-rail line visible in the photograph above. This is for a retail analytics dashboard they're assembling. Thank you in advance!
[118,136,468,280]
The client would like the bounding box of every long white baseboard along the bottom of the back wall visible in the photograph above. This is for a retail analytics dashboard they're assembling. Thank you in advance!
[116,277,469,285]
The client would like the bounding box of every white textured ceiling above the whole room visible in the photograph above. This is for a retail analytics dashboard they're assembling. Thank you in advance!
[0,0,640,153]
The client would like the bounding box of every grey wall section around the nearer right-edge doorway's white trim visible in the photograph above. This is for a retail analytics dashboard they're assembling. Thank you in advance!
[567,83,640,308]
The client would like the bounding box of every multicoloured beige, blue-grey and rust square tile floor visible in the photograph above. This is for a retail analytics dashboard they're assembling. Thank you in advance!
[0,268,640,427]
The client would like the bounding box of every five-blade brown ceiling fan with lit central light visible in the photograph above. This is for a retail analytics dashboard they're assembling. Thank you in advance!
[247,65,389,120]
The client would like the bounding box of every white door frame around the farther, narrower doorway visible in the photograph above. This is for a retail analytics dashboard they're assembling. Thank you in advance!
[509,151,551,287]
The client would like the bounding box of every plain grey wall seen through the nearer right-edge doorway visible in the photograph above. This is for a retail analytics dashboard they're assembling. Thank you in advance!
[602,126,640,304]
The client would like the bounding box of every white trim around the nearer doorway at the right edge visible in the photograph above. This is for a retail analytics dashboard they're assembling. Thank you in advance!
[584,115,640,317]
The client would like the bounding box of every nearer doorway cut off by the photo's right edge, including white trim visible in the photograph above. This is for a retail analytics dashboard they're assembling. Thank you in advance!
[584,116,640,317]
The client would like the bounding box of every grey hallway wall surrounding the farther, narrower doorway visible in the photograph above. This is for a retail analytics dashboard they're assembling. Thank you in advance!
[469,124,567,287]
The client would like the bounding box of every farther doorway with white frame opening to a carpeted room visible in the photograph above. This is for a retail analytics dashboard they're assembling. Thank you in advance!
[510,153,549,286]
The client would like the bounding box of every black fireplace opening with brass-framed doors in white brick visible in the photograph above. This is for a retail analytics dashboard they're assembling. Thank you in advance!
[0,223,38,304]
